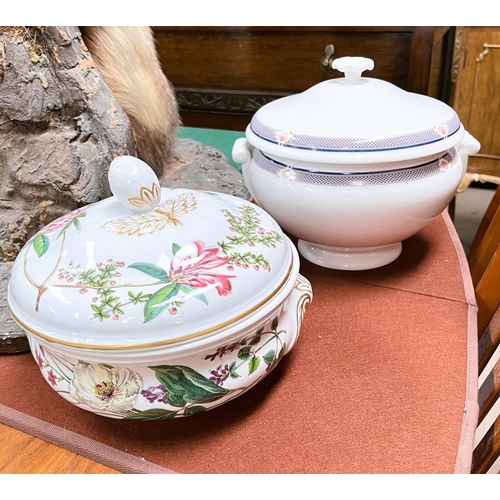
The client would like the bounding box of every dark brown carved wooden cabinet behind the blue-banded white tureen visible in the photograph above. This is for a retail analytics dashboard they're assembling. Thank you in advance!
[153,26,453,131]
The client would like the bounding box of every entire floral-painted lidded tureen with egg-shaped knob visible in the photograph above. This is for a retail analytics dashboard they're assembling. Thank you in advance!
[8,157,311,419]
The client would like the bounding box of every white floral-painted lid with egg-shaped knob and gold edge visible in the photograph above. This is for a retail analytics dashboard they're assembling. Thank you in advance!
[8,157,292,349]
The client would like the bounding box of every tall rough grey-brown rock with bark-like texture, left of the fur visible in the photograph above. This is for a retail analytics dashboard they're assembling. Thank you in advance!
[0,26,136,262]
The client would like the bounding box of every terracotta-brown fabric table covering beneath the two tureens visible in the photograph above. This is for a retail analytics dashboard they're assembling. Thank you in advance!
[0,212,477,474]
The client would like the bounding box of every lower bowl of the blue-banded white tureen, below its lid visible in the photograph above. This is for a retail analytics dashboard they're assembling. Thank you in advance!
[235,139,463,270]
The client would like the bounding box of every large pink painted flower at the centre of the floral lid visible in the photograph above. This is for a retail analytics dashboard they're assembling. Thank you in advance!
[168,241,236,297]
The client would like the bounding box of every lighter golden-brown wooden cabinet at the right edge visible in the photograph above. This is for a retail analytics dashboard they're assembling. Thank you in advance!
[449,26,500,190]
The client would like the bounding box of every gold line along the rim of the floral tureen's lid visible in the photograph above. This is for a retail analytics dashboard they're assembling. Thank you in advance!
[7,254,294,351]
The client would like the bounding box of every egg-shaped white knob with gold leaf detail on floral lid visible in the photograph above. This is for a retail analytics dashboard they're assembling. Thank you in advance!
[108,156,161,212]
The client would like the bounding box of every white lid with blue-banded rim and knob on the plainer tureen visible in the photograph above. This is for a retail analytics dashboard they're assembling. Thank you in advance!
[246,57,464,163]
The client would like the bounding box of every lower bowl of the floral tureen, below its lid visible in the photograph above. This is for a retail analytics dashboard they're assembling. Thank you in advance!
[27,275,312,420]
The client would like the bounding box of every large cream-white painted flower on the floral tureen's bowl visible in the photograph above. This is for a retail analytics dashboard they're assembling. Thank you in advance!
[69,363,142,416]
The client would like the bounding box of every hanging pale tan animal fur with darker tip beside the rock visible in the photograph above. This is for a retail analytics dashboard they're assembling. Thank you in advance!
[80,26,181,178]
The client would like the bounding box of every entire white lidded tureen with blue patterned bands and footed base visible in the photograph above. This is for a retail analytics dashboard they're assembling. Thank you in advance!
[233,57,479,270]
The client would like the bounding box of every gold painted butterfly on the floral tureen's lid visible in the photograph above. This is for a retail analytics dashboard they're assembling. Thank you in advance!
[101,193,196,236]
